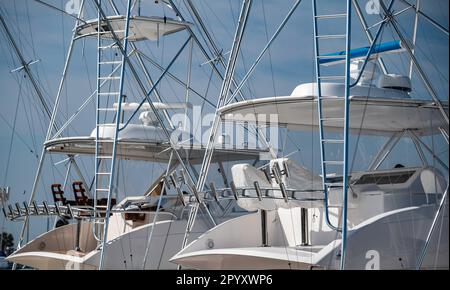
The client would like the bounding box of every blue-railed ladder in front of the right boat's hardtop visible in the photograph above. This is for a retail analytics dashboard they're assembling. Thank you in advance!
[312,0,352,269]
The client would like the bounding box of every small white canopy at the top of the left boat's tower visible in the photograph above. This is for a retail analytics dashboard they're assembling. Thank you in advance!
[76,15,191,41]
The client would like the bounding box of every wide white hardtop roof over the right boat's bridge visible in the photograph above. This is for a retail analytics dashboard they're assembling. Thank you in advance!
[219,83,448,135]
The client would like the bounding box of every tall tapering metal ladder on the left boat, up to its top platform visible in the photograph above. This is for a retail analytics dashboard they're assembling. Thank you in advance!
[94,0,131,270]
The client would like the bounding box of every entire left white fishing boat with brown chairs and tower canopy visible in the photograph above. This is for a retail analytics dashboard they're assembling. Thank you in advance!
[3,8,267,269]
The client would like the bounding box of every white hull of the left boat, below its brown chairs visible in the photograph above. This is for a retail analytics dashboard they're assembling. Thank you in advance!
[7,214,207,270]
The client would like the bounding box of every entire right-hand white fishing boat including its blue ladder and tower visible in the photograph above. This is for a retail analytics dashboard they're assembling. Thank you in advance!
[171,0,449,270]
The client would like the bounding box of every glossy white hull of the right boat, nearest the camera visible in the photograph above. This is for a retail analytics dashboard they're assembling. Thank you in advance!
[171,205,449,270]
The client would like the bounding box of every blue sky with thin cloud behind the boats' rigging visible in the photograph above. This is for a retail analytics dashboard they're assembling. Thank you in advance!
[0,0,449,245]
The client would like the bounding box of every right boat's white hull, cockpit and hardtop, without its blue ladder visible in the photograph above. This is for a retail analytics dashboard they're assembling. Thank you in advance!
[171,48,449,269]
